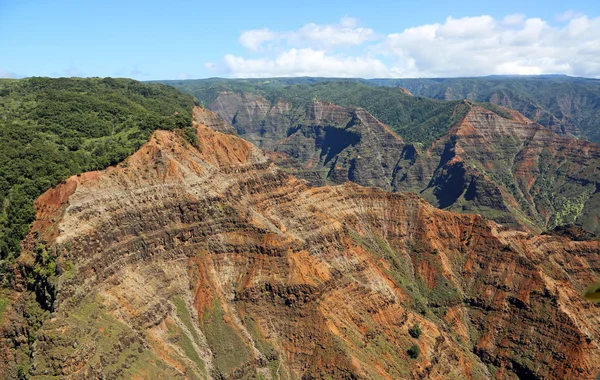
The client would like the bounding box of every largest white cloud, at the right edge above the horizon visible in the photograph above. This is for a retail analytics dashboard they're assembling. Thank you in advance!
[376,16,600,77]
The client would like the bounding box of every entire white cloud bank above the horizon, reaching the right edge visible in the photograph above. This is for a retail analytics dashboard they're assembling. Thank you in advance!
[216,11,600,78]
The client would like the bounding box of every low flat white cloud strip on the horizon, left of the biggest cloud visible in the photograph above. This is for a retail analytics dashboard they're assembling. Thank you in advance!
[225,48,388,78]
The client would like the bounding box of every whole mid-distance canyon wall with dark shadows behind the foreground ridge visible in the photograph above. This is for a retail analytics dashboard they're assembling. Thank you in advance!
[211,93,600,233]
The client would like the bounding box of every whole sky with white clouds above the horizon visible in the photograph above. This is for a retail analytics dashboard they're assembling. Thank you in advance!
[0,0,600,80]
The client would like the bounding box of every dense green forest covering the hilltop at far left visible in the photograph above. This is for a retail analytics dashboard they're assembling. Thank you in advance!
[0,78,195,281]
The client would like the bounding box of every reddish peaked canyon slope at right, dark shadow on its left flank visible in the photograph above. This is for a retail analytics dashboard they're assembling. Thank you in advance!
[423,106,600,231]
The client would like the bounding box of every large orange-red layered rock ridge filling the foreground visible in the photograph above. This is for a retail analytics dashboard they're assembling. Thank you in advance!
[0,106,600,379]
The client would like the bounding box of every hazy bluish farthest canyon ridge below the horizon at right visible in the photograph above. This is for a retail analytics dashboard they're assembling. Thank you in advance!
[370,75,600,143]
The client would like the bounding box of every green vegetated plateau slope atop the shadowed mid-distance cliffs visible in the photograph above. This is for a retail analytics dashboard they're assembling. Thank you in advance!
[166,80,468,145]
